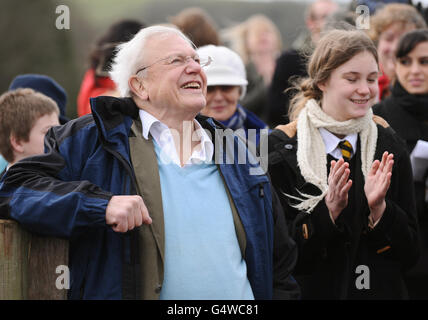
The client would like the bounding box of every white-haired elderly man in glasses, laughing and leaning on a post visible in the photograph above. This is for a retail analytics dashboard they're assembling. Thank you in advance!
[0,26,299,300]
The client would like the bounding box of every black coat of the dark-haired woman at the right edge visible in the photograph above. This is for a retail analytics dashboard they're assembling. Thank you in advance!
[373,81,428,299]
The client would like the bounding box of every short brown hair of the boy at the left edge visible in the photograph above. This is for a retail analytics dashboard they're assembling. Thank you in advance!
[0,88,59,162]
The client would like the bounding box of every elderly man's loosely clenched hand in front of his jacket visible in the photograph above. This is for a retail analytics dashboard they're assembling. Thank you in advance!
[106,196,152,232]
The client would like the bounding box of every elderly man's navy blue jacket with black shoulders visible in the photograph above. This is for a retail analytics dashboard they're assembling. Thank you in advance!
[0,97,297,299]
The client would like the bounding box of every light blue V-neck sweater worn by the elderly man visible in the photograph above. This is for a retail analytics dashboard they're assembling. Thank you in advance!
[154,141,254,300]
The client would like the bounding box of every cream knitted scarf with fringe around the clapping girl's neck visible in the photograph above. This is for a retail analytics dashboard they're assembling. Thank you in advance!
[287,99,377,213]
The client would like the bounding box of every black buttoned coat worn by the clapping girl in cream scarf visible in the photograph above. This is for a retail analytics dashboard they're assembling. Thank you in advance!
[269,118,419,299]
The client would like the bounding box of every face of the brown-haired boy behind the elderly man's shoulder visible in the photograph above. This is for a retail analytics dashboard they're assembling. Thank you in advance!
[17,112,59,160]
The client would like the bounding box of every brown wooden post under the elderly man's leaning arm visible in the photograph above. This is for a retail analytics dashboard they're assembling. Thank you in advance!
[0,220,69,300]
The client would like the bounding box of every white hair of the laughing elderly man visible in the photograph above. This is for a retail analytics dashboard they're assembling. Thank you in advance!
[109,25,194,97]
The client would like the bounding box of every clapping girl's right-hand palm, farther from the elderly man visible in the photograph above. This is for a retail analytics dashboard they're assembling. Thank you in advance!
[364,151,394,222]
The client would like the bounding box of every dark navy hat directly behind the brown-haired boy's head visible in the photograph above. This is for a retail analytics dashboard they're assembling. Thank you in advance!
[9,74,70,124]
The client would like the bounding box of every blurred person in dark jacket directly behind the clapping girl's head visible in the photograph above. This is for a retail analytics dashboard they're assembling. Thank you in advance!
[266,0,339,128]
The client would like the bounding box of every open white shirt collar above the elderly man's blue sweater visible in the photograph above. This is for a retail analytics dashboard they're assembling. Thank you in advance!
[139,109,214,166]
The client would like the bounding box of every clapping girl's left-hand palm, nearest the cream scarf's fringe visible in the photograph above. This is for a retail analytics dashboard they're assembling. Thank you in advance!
[324,158,352,221]
